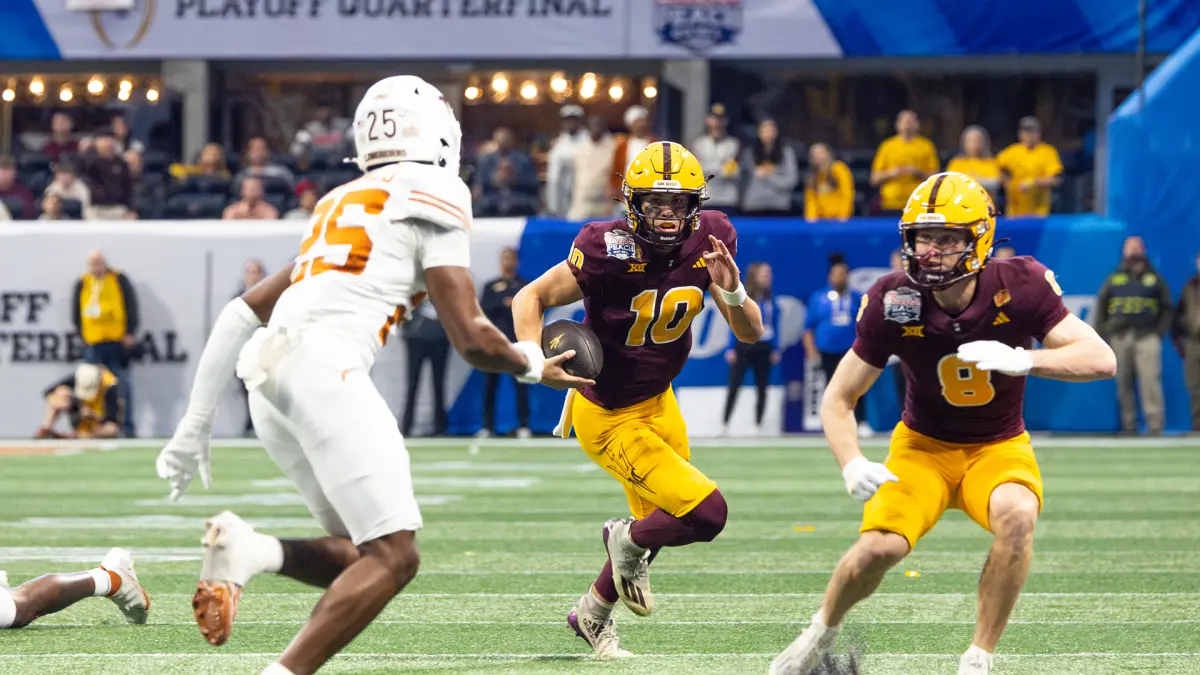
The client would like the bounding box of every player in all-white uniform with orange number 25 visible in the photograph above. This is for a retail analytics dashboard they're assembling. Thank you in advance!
[158,76,590,675]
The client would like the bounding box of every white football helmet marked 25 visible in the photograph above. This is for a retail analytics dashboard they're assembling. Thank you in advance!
[354,74,462,175]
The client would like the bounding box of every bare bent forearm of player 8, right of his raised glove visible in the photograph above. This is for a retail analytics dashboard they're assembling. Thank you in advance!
[1030,315,1117,382]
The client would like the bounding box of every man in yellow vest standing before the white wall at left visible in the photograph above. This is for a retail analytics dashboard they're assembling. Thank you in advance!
[74,251,140,438]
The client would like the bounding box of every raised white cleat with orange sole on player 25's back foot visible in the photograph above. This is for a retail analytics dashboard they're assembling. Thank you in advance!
[192,510,262,646]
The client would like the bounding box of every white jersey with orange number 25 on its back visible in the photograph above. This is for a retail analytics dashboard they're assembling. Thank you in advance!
[269,162,472,369]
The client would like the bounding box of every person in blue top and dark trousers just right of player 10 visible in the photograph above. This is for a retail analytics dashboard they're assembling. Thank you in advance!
[722,263,780,435]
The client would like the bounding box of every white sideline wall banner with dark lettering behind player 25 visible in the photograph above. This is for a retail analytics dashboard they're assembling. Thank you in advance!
[0,219,524,438]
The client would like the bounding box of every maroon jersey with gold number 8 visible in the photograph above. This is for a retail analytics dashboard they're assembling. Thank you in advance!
[853,256,1069,443]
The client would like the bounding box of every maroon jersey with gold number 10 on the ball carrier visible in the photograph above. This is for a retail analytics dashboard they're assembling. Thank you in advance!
[566,211,738,410]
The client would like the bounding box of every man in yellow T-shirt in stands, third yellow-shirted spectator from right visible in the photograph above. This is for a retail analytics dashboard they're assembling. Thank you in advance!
[870,110,941,217]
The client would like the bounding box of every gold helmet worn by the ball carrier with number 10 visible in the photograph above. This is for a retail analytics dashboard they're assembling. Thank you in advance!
[620,141,708,249]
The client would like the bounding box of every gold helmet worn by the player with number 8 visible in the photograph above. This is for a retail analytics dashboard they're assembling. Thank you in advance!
[900,172,996,287]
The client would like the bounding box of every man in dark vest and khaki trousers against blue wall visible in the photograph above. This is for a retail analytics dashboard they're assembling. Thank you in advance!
[1094,237,1171,434]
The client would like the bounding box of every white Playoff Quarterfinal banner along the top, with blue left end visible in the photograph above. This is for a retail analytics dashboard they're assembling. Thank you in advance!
[16,0,841,59]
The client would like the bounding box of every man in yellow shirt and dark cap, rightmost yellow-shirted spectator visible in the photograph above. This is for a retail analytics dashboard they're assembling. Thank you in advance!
[996,117,1062,217]
